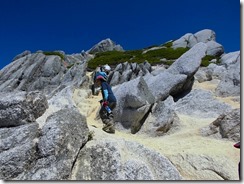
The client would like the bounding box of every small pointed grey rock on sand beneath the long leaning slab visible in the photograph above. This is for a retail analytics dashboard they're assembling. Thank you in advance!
[140,96,179,136]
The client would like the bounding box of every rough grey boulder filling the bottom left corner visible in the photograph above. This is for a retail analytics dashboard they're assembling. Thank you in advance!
[0,123,39,180]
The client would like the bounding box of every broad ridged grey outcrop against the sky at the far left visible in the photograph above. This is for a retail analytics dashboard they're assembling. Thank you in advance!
[0,52,87,95]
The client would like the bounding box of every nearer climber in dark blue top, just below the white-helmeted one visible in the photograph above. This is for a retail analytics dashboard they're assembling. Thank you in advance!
[95,75,117,133]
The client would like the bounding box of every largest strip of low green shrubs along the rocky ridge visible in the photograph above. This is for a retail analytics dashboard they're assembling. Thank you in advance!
[88,45,189,69]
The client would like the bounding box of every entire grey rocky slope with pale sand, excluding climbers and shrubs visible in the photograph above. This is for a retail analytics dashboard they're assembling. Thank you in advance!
[0,30,240,180]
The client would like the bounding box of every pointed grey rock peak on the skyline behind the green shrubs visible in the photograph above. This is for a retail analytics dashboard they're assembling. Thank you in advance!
[87,38,124,54]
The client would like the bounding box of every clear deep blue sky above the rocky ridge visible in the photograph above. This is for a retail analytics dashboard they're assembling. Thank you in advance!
[0,0,241,69]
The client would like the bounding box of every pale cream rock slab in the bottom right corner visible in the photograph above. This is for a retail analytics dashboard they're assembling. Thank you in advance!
[170,153,238,181]
